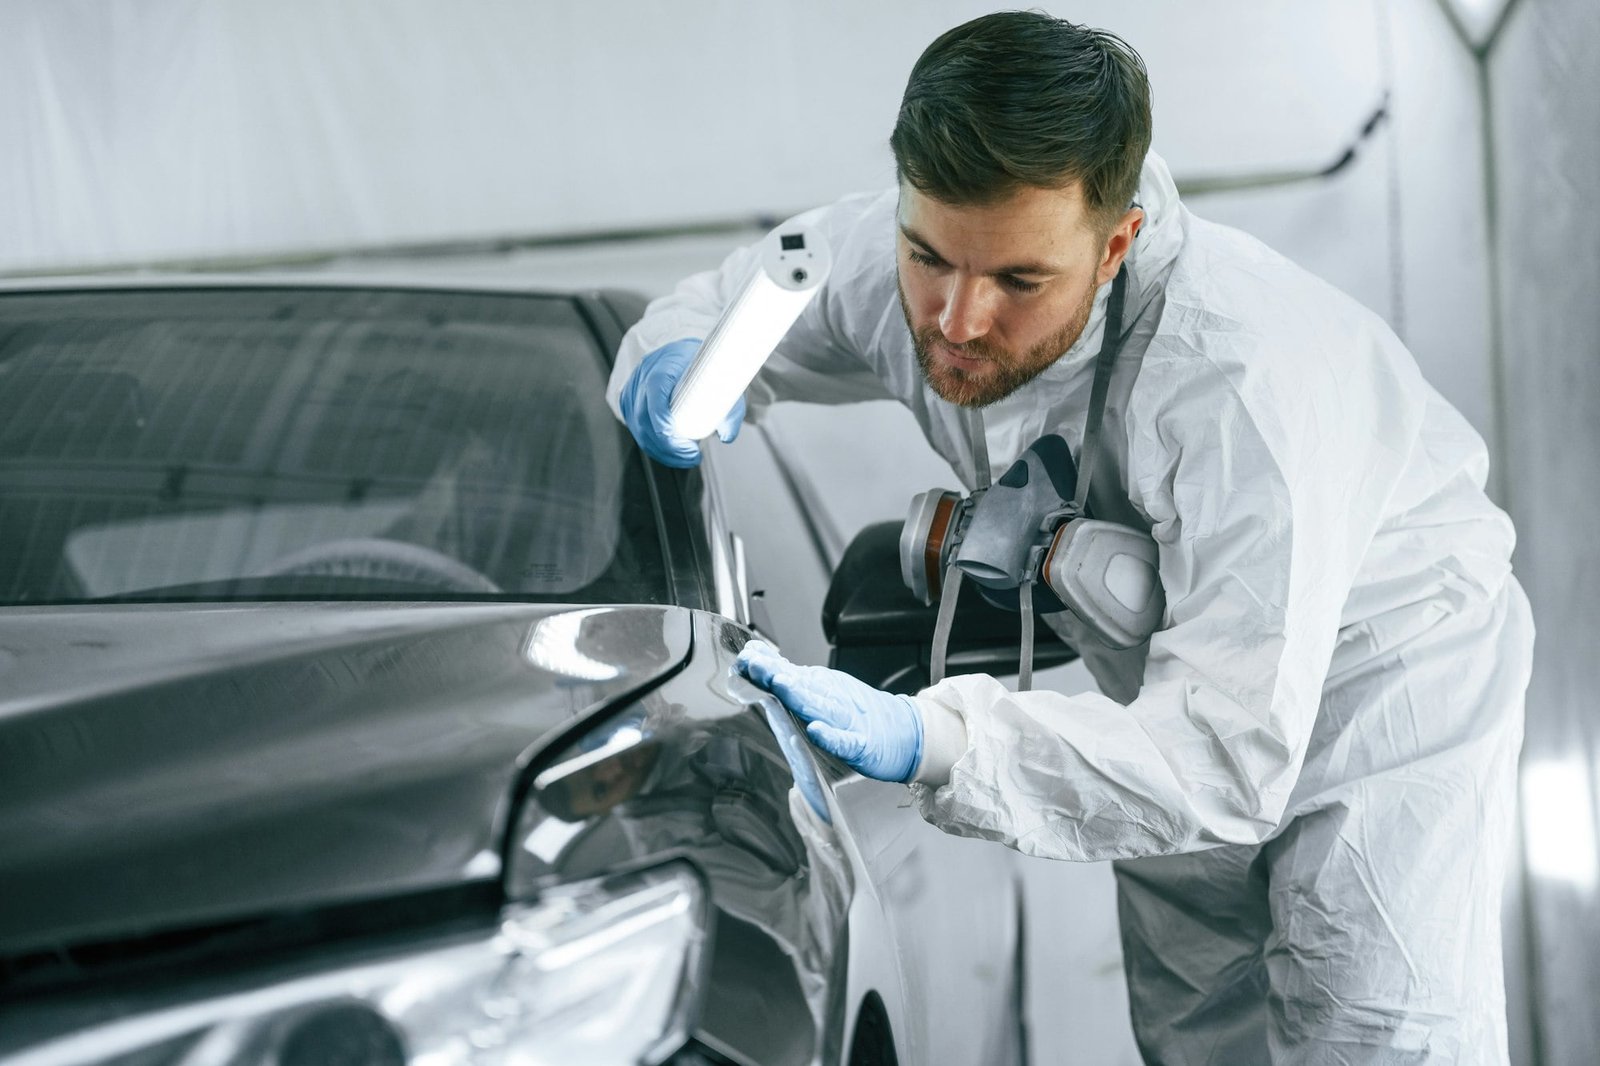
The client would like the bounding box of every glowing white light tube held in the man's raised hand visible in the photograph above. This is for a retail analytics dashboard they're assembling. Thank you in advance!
[672,222,834,440]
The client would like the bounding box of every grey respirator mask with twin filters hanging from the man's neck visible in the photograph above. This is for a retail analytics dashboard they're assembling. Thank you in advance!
[899,267,1166,691]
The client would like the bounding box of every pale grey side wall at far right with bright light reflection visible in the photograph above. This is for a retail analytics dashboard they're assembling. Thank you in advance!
[1490,0,1600,1066]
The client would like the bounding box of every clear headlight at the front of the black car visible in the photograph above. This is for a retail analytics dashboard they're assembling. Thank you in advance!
[11,863,707,1066]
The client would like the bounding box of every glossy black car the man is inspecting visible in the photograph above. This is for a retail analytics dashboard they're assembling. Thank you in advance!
[0,280,1026,1066]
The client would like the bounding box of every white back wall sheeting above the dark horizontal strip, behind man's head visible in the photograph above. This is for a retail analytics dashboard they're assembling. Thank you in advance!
[0,0,1378,272]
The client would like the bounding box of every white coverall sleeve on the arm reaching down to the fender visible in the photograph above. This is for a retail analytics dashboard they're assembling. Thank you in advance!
[912,357,1397,861]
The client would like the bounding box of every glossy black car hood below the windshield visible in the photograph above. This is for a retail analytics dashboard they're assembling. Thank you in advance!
[0,603,691,954]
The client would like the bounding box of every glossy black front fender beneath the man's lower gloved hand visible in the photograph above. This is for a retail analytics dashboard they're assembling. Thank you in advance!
[507,613,854,1066]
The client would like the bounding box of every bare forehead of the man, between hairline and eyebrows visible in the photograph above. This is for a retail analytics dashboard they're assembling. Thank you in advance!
[896,182,1093,274]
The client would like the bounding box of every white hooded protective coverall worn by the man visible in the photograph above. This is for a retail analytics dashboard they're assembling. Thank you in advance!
[608,154,1533,1063]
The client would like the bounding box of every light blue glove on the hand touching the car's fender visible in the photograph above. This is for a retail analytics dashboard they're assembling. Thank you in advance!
[734,640,922,781]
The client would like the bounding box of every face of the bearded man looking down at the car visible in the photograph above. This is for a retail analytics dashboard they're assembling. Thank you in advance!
[896,182,1142,407]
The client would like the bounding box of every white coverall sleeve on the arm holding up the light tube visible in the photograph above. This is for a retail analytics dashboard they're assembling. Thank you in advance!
[606,194,894,421]
